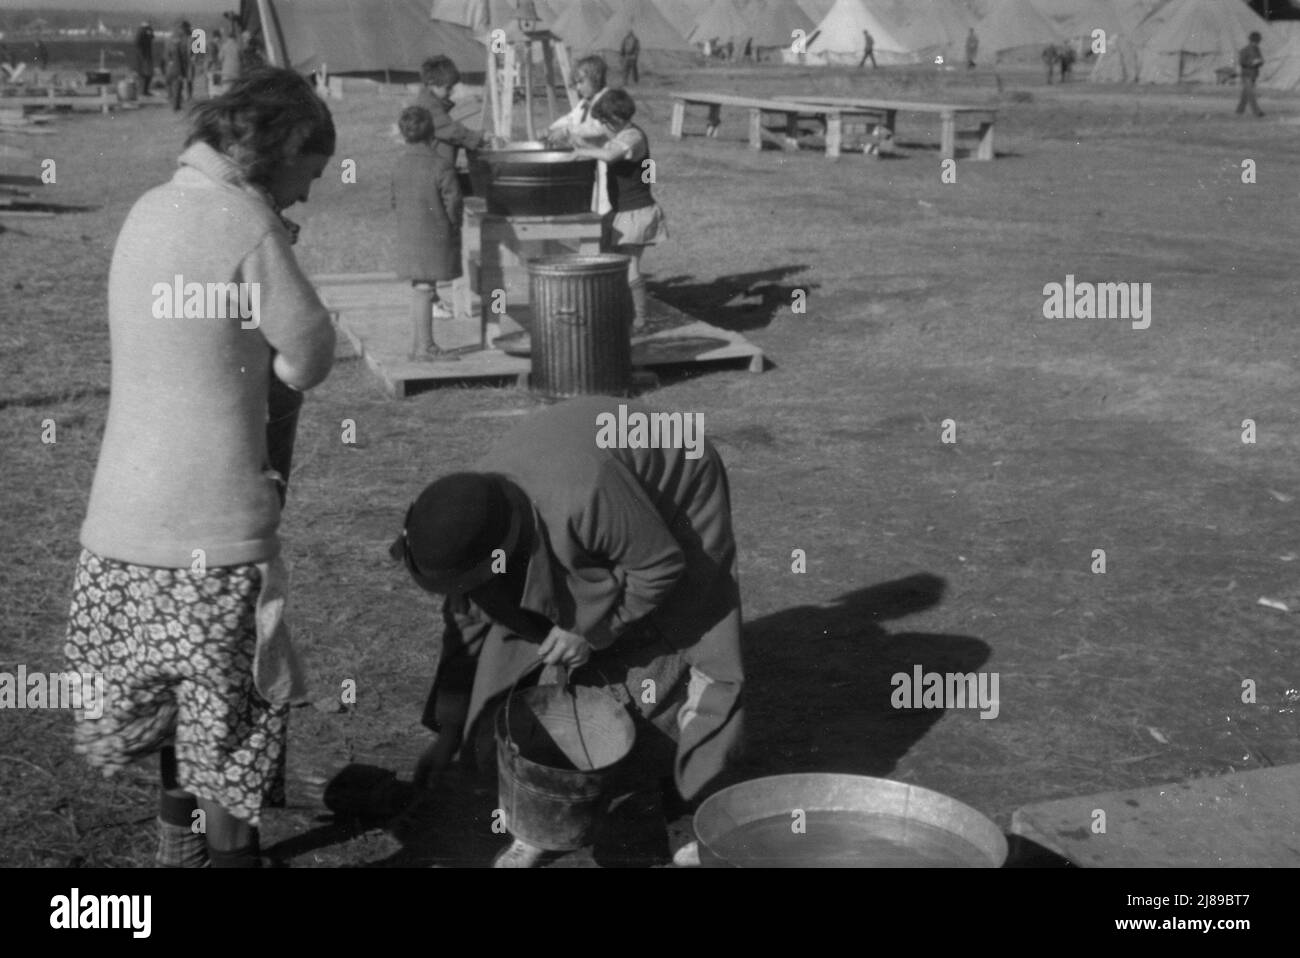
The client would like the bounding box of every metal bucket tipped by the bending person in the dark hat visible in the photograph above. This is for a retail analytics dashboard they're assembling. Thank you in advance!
[497,685,636,851]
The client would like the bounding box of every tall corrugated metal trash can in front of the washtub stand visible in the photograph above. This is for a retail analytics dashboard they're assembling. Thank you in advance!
[528,253,632,398]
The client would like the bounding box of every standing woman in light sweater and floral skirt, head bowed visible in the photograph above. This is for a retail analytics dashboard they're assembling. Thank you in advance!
[65,69,334,867]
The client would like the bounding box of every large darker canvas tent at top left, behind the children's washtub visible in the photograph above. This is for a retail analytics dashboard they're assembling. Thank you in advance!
[241,0,485,81]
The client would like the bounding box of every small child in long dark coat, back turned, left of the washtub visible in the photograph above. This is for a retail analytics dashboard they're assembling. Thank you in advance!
[393,107,463,361]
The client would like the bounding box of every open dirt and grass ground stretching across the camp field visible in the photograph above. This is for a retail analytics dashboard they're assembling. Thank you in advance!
[0,59,1300,867]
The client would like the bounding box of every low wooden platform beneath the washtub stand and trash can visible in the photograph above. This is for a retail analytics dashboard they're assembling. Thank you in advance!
[312,273,764,399]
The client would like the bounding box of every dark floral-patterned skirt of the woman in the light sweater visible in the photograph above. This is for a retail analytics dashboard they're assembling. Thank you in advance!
[64,550,289,825]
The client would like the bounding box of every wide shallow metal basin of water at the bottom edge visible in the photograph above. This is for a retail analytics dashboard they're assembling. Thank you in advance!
[694,773,1006,868]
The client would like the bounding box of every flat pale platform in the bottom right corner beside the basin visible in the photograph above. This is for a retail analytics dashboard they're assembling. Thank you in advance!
[1011,766,1300,868]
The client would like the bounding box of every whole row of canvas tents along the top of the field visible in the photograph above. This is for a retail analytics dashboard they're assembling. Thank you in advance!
[243,0,1300,88]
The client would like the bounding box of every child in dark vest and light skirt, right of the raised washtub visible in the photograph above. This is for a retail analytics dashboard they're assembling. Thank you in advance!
[573,90,668,331]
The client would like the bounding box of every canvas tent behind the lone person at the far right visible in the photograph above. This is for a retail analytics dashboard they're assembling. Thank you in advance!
[1138,0,1269,83]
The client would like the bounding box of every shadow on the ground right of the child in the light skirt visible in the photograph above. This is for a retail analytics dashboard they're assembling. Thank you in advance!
[646,264,818,333]
